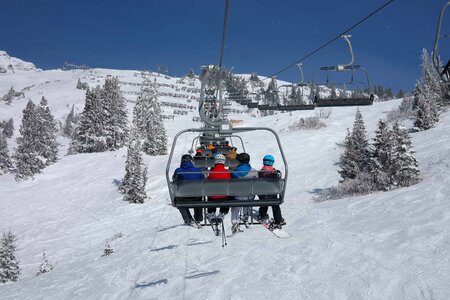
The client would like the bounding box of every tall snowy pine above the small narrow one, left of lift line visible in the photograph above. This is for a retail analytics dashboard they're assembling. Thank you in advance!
[133,74,167,155]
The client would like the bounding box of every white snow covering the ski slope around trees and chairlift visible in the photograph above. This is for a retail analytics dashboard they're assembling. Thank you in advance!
[0,51,450,299]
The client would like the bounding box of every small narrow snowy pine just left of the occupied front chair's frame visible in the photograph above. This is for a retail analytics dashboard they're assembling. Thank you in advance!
[119,134,147,203]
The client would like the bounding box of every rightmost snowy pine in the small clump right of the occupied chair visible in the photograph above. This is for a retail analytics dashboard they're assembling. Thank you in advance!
[391,122,420,187]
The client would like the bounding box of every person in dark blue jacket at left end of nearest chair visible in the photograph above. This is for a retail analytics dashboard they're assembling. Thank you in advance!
[173,154,205,224]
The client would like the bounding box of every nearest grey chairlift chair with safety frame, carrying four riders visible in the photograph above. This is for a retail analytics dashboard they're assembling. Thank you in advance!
[166,58,288,213]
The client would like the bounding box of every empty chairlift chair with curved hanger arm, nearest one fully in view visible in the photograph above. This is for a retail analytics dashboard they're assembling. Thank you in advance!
[312,35,374,107]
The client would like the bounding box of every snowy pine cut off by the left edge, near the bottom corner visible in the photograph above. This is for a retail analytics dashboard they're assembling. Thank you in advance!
[0,232,20,283]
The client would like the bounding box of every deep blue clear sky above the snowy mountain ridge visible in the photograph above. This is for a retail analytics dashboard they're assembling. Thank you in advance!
[0,0,450,91]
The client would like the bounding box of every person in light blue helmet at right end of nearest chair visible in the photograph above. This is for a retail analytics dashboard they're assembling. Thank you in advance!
[258,154,286,229]
